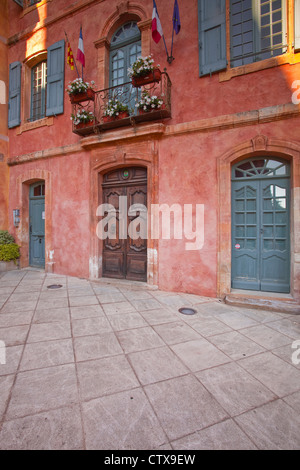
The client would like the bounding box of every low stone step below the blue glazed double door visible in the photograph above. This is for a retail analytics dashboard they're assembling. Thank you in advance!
[224,293,300,315]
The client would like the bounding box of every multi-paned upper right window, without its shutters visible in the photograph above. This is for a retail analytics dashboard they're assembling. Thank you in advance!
[230,0,286,67]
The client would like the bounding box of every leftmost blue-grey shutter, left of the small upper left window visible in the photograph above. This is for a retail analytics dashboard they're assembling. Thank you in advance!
[8,62,22,128]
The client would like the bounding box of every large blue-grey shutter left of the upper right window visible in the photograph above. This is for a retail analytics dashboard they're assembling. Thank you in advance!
[198,0,227,76]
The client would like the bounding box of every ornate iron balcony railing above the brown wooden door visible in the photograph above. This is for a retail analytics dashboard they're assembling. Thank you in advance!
[72,72,171,136]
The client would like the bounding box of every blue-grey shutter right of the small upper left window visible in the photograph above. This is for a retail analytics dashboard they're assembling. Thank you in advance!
[46,40,65,116]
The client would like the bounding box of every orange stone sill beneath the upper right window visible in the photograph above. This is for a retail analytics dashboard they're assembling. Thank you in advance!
[219,53,300,82]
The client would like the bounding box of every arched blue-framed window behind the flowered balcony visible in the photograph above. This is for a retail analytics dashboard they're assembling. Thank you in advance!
[109,21,141,87]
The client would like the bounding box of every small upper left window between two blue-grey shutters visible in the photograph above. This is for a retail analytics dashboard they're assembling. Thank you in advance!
[30,61,47,121]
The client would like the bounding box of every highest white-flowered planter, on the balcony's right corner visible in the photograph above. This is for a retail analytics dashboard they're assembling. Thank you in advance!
[128,55,161,87]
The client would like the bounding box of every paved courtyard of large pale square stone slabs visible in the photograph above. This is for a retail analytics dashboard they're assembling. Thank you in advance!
[0,269,300,450]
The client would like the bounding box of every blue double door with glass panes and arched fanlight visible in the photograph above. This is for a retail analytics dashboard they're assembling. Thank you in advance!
[232,158,290,292]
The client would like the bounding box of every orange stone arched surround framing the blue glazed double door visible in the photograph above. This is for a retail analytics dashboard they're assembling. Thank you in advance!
[217,135,300,300]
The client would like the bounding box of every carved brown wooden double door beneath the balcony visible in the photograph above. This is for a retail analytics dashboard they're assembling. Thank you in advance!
[102,167,147,282]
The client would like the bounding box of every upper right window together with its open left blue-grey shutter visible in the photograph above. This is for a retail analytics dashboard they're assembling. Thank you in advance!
[198,0,300,76]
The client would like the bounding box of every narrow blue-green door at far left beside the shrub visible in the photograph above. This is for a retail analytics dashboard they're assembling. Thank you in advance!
[29,183,45,268]
